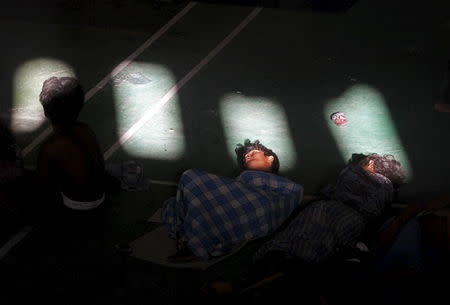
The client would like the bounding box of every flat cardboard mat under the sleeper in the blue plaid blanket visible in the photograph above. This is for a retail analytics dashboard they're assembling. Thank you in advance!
[130,209,245,270]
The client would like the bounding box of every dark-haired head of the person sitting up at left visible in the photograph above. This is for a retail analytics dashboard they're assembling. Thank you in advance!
[39,76,84,126]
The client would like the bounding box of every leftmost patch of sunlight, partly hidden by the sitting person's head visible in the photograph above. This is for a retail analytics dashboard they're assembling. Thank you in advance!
[11,58,75,133]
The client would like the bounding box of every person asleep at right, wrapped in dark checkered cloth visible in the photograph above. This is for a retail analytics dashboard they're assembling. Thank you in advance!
[210,154,405,293]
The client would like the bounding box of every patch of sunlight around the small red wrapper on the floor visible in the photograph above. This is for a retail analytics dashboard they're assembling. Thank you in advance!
[324,84,413,180]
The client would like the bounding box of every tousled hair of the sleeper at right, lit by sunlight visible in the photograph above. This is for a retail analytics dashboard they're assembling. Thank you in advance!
[349,153,406,188]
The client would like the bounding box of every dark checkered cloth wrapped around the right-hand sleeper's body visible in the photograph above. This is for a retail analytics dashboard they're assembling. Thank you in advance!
[254,165,393,263]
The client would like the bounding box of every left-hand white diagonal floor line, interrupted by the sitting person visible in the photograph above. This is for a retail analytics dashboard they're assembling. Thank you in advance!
[22,2,197,157]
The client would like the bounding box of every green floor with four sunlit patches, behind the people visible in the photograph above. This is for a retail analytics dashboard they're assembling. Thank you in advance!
[0,1,450,197]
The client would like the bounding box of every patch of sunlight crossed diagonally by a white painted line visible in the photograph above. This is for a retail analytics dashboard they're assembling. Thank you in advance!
[112,62,185,160]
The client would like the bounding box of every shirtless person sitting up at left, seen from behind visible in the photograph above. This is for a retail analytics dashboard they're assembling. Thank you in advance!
[37,77,105,210]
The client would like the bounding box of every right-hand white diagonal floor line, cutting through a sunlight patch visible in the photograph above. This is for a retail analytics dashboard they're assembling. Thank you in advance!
[103,7,262,160]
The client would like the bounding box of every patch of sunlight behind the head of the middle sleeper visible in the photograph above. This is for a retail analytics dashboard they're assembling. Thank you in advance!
[220,94,297,171]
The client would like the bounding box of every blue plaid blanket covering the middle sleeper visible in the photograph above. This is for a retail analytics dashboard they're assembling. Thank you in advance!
[162,170,303,259]
